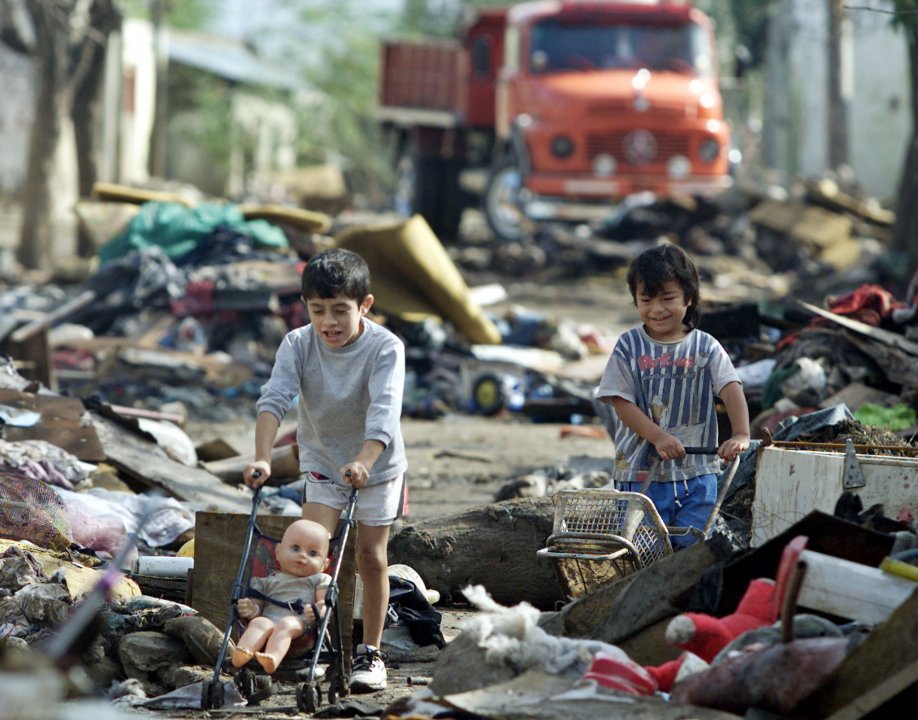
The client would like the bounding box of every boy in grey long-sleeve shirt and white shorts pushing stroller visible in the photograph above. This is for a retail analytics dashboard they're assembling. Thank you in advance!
[243,248,407,692]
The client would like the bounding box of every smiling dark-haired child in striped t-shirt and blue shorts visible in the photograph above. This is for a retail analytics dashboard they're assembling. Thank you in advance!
[596,244,750,546]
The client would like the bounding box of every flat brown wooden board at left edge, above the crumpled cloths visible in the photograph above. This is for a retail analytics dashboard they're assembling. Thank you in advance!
[0,388,105,463]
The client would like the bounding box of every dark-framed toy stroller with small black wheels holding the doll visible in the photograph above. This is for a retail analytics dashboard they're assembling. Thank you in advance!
[201,480,357,714]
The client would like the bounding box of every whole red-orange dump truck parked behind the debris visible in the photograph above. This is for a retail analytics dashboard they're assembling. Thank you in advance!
[377,0,731,240]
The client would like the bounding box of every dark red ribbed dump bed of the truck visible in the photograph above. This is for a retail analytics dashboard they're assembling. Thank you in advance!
[379,41,468,124]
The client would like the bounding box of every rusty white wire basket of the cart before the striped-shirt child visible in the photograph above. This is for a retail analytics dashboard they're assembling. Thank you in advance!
[537,490,673,598]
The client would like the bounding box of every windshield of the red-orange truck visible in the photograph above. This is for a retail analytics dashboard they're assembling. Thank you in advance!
[529,19,713,75]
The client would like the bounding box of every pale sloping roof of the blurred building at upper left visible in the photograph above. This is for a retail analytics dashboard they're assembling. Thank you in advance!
[168,30,303,90]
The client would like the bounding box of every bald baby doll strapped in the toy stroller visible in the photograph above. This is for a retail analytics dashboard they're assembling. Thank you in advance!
[232,520,331,674]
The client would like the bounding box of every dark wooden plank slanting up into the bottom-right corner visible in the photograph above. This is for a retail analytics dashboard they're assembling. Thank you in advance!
[793,592,918,720]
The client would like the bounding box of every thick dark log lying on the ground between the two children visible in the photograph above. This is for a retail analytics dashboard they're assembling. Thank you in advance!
[389,498,564,609]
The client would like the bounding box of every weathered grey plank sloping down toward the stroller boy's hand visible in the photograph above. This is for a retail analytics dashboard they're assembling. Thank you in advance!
[93,414,251,512]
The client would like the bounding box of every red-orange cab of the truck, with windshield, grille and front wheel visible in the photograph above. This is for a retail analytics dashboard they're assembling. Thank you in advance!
[484,1,731,238]
